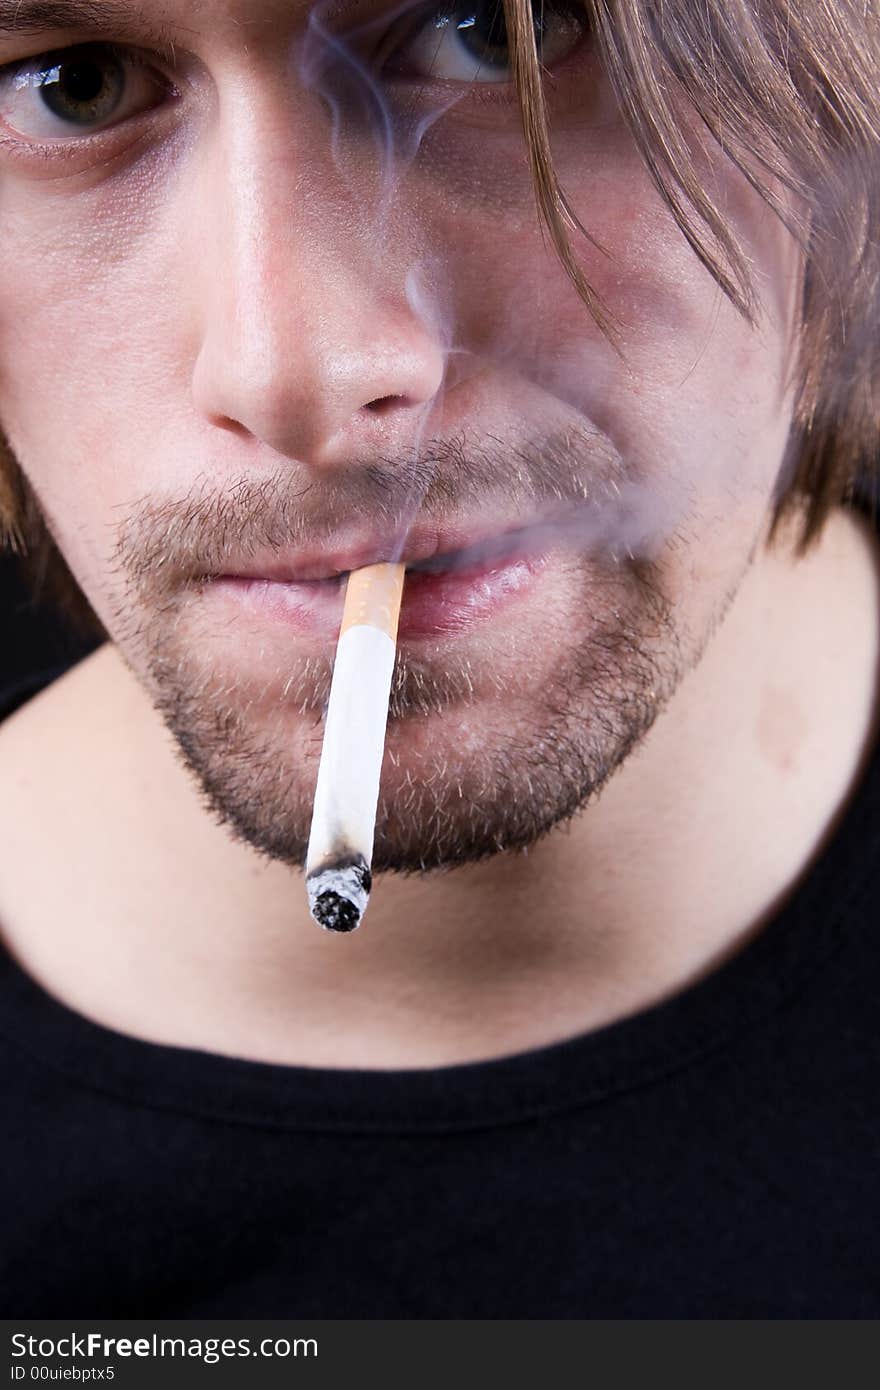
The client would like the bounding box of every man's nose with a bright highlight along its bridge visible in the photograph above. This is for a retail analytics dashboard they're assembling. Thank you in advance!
[189,103,445,468]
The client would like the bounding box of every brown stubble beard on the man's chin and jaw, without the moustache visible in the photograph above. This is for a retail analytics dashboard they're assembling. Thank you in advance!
[132,547,692,873]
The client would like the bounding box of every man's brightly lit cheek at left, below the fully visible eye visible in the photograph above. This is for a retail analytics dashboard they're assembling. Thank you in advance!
[0,159,196,596]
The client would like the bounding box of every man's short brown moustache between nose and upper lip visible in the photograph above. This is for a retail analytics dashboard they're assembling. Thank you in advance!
[113,424,684,606]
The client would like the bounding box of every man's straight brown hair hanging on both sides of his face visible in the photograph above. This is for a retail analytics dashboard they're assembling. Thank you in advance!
[0,0,880,635]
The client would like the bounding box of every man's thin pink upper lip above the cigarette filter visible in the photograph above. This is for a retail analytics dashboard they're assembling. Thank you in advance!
[212,518,542,584]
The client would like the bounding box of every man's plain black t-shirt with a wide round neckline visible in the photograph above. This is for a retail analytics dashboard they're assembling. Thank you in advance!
[0,656,880,1318]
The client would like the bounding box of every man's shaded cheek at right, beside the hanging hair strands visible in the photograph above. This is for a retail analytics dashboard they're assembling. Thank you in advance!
[435,135,798,525]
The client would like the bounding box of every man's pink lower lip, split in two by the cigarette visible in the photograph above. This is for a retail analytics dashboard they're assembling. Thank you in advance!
[210,556,546,639]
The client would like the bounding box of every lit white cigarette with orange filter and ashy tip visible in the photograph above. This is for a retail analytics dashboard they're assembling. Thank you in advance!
[306,564,405,931]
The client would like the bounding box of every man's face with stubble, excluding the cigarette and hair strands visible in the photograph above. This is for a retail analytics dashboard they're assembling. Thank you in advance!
[0,0,798,867]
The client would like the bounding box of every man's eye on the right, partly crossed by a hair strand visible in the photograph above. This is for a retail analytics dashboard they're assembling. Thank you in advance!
[385,0,588,82]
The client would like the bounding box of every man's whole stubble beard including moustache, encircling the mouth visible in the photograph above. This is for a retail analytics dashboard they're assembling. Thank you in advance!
[95,432,748,873]
